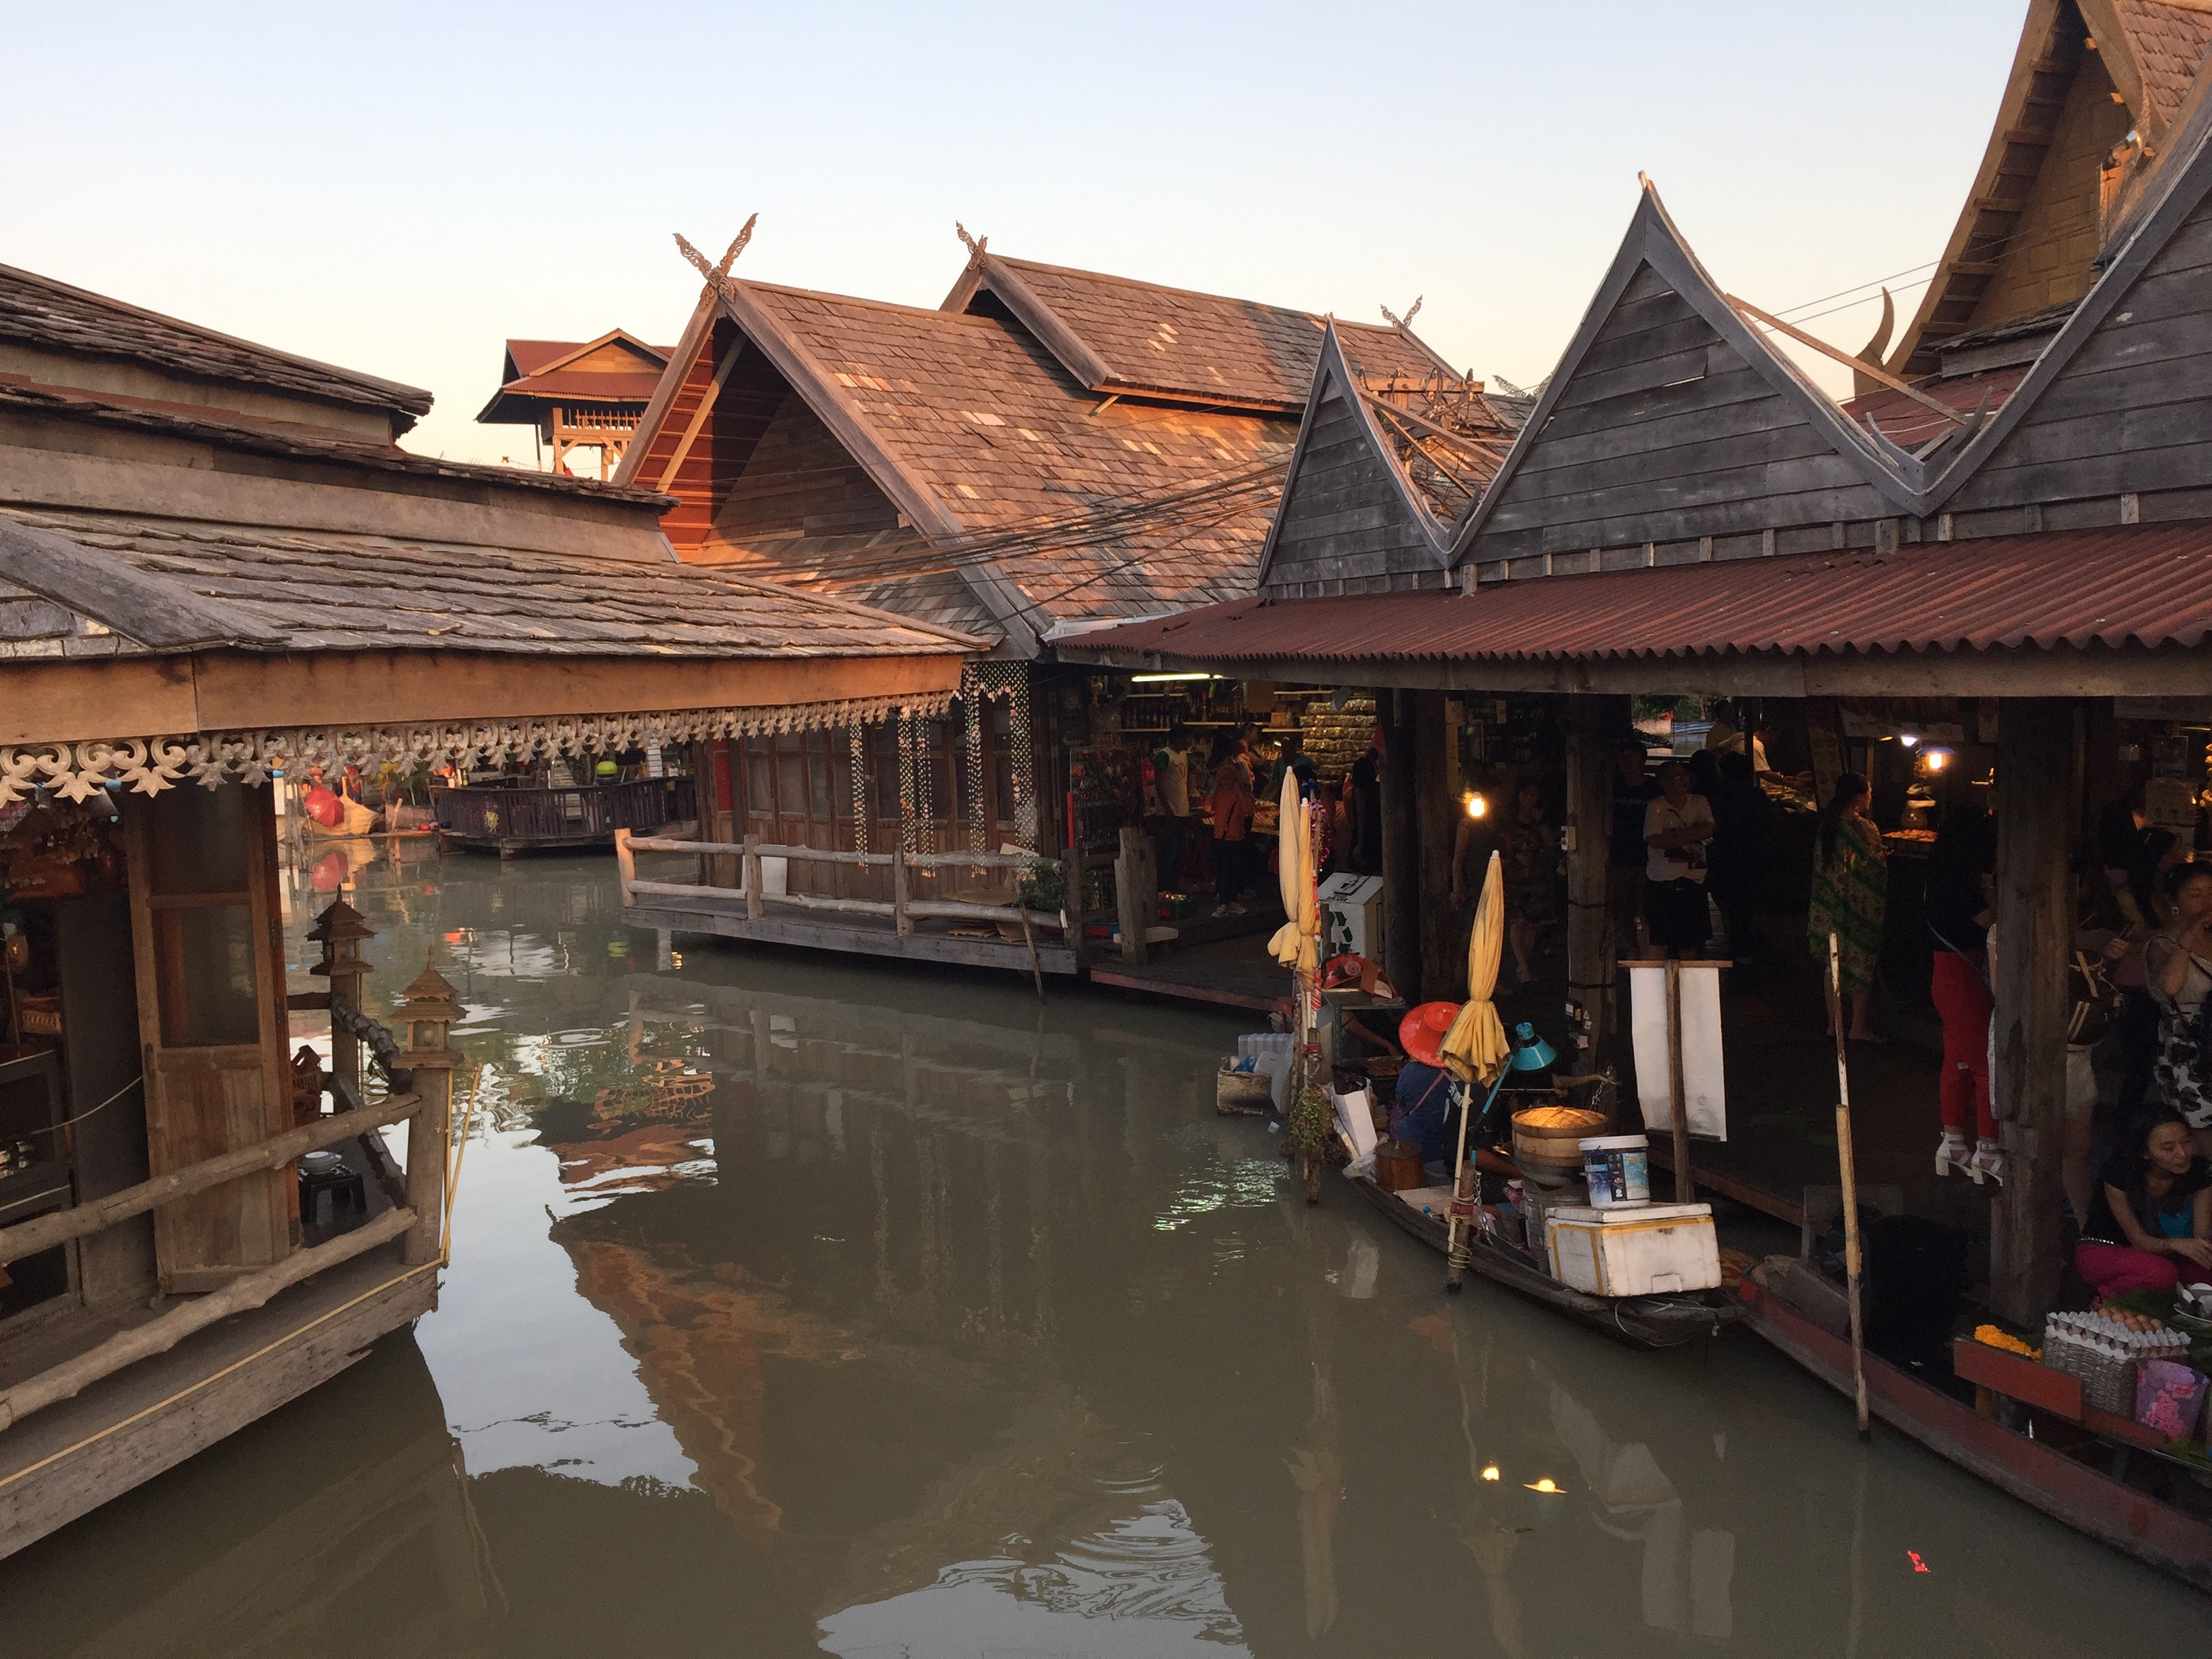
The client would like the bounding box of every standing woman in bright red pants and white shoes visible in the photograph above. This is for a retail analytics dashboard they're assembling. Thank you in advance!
[1927,805,2004,1181]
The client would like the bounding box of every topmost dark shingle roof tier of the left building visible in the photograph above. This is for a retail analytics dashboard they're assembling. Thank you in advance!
[0,266,431,431]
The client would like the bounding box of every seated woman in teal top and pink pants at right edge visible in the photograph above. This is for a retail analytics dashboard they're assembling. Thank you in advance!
[2075,1106,2212,1300]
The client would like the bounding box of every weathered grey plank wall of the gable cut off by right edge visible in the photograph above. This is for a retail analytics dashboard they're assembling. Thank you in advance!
[1949,188,2212,533]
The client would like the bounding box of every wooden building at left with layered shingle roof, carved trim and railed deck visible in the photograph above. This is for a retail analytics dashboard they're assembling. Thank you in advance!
[0,268,975,1553]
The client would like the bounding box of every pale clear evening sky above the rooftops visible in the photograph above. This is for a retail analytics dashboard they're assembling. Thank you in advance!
[0,0,2026,464]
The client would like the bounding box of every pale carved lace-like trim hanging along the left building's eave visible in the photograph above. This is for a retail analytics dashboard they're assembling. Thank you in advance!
[0,690,956,805]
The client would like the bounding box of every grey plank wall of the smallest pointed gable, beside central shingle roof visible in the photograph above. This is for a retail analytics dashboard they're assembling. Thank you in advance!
[1265,387,1444,593]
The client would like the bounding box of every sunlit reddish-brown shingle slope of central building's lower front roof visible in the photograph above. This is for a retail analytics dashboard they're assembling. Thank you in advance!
[705,283,1303,623]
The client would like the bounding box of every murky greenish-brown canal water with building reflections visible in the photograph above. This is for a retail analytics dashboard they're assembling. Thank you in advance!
[0,847,2207,1659]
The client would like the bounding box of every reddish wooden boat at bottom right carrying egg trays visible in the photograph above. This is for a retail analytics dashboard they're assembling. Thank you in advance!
[1743,1274,2212,1591]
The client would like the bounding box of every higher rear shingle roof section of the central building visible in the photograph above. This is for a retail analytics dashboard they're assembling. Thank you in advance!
[940,252,1458,413]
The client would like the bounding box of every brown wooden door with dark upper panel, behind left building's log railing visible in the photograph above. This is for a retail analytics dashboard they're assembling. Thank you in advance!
[124,785,294,1292]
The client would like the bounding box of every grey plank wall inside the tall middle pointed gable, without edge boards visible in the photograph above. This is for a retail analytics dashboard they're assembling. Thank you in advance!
[1471,268,1893,575]
